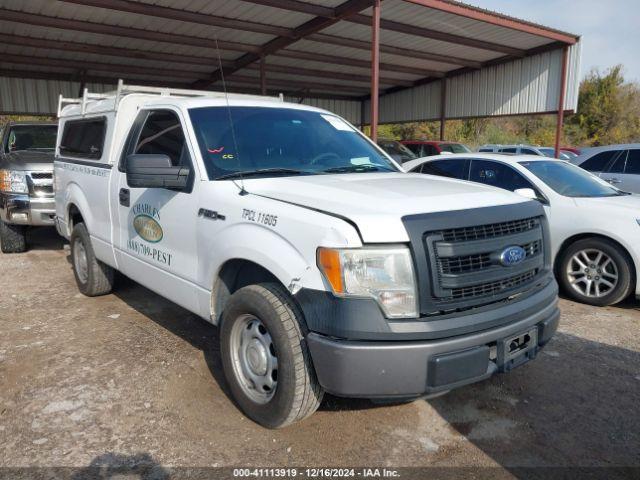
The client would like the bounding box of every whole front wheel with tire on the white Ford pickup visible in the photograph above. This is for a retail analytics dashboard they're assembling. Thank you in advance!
[220,283,324,428]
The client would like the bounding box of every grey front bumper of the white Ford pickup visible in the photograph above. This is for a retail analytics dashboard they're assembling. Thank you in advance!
[307,300,560,399]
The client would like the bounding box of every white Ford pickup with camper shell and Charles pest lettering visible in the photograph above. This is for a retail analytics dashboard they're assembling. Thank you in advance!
[55,84,560,428]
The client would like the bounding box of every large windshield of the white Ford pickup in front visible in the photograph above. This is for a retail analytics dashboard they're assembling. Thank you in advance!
[189,107,398,180]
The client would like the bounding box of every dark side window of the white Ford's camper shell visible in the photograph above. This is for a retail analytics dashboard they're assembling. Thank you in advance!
[60,117,107,160]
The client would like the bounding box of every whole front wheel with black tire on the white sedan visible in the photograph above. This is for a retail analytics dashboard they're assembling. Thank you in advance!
[558,237,634,307]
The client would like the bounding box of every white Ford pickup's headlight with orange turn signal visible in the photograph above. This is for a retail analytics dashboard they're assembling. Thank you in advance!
[318,245,418,318]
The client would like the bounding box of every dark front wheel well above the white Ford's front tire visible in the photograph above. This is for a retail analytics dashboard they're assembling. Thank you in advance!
[211,259,282,323]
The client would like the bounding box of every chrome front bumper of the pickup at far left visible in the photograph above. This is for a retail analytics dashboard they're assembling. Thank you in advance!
[0,192,56,226]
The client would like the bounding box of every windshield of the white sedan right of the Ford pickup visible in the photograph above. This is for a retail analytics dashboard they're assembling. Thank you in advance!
[520,160,626,197]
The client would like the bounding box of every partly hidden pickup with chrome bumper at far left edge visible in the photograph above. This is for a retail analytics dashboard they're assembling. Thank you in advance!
[0,122,58,253]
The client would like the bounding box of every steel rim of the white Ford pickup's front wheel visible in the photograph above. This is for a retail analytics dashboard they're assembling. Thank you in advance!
[230,315,278,404]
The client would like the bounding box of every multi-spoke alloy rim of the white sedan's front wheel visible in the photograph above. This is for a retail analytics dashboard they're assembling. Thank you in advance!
[566,248,620,298]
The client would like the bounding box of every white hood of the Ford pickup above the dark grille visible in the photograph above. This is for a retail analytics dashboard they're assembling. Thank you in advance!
[244,173,528,243]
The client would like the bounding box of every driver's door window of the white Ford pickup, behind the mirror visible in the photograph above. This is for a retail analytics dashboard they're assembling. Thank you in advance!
[133,110,191,167]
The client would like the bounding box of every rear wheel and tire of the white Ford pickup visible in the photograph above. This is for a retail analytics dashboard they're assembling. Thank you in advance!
[69,223,114,297]
